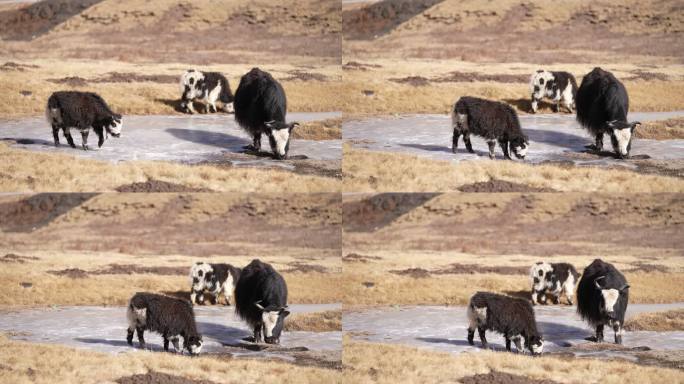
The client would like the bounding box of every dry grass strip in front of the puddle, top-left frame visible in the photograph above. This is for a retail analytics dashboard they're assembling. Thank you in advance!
[0,143,340,192]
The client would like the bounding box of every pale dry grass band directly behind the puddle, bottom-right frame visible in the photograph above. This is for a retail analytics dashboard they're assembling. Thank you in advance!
[343,250,684,306]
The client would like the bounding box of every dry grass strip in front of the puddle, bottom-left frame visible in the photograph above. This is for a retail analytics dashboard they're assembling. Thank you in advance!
[0,335,341,384]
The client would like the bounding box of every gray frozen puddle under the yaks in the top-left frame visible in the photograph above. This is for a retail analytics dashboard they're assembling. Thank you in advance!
[0,112,342,167]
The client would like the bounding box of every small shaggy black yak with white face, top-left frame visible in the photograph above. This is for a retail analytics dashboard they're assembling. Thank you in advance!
[45,91,123,150]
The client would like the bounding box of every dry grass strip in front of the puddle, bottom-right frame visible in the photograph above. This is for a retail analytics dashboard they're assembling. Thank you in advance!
[342,338,684,384]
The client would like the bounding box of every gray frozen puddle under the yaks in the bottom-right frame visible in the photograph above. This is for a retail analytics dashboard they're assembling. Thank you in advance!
[342,303,684,356]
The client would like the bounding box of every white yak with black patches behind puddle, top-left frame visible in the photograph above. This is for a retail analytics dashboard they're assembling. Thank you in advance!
[180,69,233,113]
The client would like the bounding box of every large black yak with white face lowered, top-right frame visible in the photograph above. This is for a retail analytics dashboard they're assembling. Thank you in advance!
[575,67,641,159]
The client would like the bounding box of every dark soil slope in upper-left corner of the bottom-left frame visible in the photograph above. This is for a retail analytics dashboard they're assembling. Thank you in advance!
[0,193,97,232]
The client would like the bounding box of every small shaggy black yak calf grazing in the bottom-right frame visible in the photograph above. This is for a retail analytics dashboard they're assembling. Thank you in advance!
[468,292,544,355]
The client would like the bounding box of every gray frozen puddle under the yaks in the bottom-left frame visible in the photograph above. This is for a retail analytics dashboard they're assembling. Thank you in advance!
[0,304,342,358]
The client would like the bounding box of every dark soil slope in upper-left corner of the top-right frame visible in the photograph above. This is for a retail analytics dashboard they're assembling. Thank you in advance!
[342,0,443,40]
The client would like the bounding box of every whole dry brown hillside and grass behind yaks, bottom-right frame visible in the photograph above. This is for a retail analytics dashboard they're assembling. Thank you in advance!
[342,193,684,307]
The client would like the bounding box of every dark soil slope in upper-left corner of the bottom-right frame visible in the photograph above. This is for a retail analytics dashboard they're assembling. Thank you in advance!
[342,193,439,232]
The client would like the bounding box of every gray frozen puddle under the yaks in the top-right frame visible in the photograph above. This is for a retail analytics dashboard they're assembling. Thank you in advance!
[342,111,684,167]
